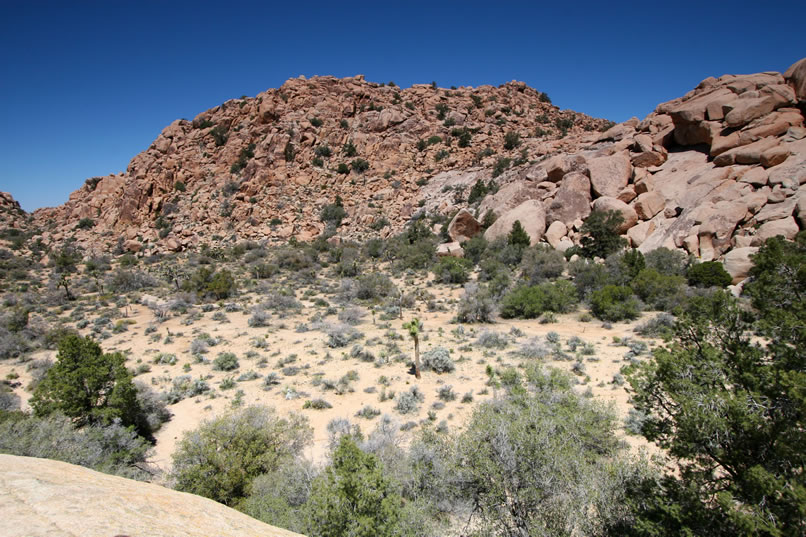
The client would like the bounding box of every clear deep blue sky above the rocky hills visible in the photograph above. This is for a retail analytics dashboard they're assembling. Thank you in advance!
[0,0,806,211]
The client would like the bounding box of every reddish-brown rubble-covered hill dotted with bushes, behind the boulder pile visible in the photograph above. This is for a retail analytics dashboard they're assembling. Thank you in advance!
[30,76,607,250]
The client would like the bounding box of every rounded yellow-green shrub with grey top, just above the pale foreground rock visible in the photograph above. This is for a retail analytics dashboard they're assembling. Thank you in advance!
[171,406,311,505]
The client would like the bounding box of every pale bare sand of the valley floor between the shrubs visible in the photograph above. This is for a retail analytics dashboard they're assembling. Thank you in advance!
[0,276,657,470]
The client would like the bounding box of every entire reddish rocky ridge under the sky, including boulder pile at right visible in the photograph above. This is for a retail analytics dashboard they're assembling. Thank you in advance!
[6,59,806,280]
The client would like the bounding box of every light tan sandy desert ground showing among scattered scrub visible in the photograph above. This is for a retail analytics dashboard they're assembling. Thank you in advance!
[0,274,659,470]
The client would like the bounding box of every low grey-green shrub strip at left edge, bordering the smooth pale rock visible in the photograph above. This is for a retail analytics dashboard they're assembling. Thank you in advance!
[0,412,151,480]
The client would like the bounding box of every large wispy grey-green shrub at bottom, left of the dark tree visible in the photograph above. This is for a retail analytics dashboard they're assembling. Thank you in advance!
[457,368,642,535]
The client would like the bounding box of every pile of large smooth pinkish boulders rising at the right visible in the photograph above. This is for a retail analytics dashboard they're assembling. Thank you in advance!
[442,59,806,272]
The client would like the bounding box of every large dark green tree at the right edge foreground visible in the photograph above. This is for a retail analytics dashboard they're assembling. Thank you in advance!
[628,233,806,537]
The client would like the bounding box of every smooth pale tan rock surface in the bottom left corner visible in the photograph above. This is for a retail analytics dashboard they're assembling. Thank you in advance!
[0,454,299,537]
